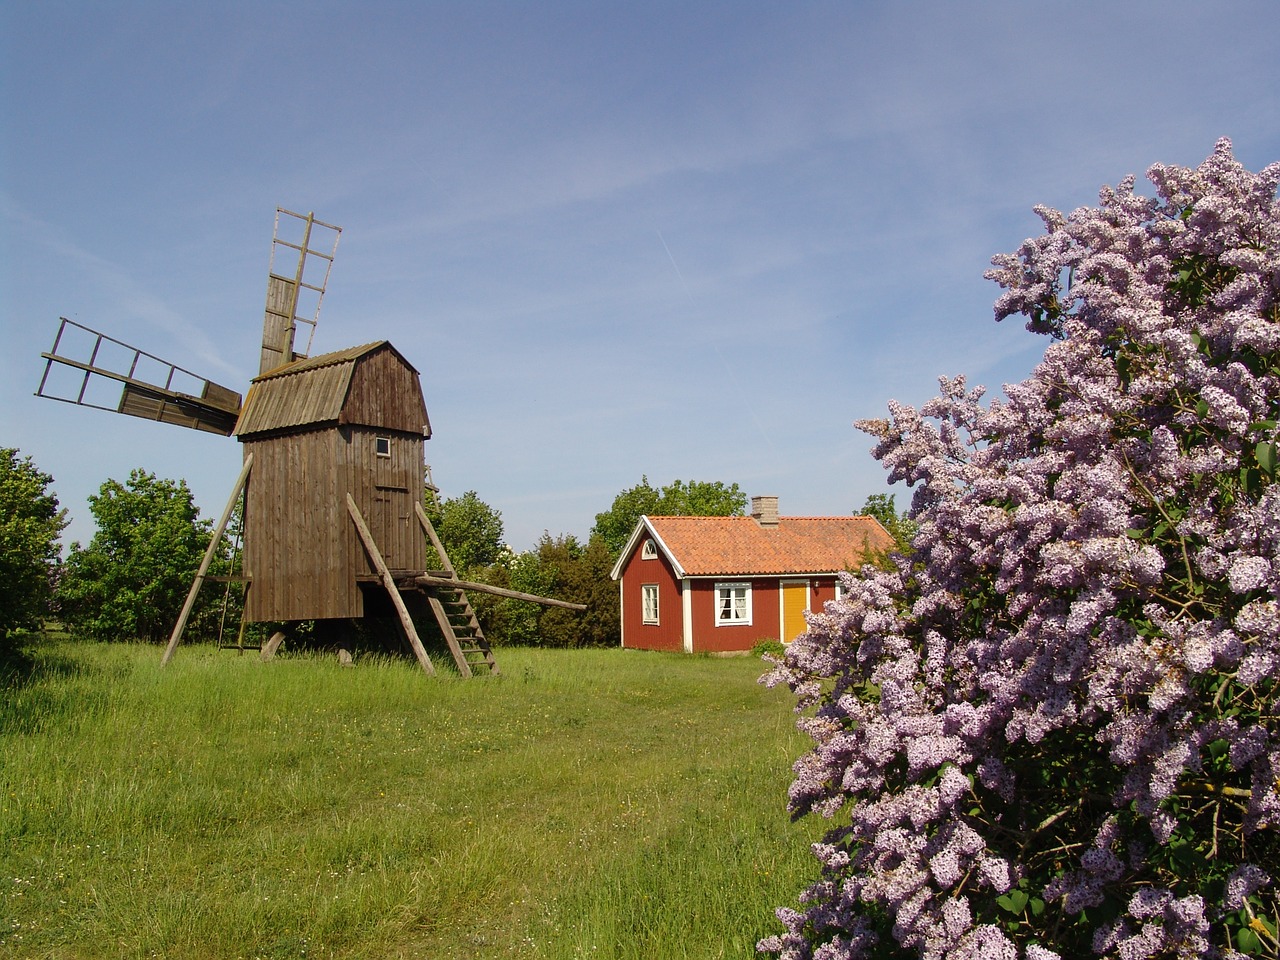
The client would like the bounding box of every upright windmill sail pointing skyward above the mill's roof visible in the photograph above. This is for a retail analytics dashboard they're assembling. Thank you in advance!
[259,207,342,374]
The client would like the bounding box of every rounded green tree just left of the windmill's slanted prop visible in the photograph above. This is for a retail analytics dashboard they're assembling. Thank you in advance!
[58,470,214,643]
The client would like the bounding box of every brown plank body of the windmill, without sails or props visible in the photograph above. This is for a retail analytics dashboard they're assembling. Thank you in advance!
[236,340,435,621]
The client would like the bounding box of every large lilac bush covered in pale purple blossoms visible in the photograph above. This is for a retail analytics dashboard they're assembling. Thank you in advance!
[760,140,1280,960]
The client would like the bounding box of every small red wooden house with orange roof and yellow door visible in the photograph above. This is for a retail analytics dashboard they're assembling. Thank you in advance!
[612,497,892,653]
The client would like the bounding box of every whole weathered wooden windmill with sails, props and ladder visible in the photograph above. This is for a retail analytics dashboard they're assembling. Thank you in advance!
[36,209,585,676]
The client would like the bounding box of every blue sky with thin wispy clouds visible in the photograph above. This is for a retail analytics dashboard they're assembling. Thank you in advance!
[0,0,1280,549]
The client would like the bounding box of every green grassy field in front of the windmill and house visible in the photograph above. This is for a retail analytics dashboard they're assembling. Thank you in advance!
[0,644,820,960]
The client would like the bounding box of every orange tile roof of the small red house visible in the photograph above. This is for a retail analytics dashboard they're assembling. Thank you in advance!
[632,517,893,576]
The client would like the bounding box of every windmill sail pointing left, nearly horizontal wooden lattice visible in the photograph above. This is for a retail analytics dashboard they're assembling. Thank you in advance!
[36,317,241,436]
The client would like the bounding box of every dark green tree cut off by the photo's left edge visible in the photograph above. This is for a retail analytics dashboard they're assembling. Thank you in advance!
[0,447,67,655]
